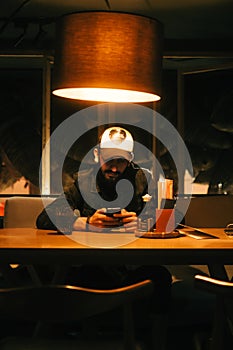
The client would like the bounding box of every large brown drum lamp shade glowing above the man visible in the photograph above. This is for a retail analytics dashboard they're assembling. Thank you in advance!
[53,11,163,102]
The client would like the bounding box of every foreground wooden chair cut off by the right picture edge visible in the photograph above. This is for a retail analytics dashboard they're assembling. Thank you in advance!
[195,275,233,350]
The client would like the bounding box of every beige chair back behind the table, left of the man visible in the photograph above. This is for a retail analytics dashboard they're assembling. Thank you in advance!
[3,196,55,228]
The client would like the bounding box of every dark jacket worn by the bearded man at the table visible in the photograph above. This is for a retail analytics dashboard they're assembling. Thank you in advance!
[37,163,155,230]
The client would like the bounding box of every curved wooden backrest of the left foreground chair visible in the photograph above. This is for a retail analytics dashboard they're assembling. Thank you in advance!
[0,280,153,323]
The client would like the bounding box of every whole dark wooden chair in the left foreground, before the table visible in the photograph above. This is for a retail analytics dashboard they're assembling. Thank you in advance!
[0,280,153,350]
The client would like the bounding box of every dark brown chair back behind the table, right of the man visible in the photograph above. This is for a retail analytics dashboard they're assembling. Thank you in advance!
[185,195,233,227]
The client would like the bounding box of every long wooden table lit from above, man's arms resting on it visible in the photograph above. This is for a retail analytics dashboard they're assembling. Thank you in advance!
[0,228,233,265]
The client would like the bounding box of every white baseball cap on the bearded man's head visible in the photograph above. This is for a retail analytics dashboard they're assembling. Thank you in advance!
[100,126,134,162]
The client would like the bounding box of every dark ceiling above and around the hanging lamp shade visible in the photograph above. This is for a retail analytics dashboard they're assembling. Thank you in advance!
[0,0,233,51]
